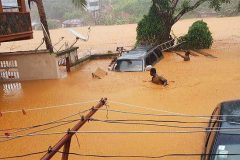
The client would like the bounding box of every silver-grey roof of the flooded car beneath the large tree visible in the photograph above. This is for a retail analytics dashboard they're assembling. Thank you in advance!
[118,46,151,60]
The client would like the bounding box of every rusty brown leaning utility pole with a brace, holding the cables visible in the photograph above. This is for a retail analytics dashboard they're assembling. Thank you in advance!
[41,98,107,160]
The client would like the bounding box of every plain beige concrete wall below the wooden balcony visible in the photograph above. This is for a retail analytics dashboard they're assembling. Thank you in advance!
[0,51,60,80]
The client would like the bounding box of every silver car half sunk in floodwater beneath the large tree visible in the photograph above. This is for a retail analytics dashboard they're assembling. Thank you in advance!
[111,47,163,72]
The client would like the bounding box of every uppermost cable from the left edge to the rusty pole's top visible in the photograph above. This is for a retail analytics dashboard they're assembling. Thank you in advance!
[1,100,98,114]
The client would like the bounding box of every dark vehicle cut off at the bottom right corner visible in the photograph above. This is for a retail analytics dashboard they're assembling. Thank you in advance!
[201,100,240,160]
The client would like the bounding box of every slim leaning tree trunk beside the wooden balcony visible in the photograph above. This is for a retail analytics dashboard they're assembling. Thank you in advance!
[35,0,53,53]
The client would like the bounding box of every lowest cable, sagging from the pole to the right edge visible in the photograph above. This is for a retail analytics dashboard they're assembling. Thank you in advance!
[57,151,240,159]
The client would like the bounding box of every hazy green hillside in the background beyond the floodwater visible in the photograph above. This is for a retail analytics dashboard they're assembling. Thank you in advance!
[31,0,240,28]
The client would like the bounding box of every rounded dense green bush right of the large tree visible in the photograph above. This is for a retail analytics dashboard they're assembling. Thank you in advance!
[182,20,213,49]
